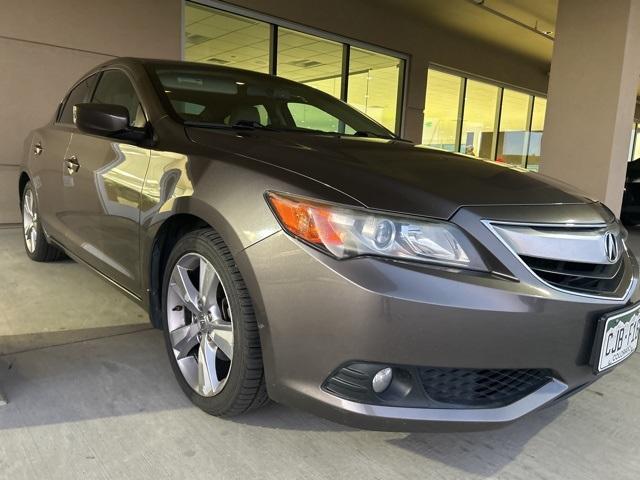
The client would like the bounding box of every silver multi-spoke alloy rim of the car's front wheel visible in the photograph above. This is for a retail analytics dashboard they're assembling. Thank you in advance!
[166,253,233,397]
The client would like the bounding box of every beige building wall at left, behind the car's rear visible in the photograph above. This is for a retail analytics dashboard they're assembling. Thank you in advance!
[0,0,182,224]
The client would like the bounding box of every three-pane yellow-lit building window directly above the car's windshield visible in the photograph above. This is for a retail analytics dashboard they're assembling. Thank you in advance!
[184,1,405,131]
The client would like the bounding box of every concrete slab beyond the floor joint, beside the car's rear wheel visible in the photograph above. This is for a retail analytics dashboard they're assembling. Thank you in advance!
[0,228,150,355]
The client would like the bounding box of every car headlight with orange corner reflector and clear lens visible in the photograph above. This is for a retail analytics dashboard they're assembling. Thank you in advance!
[267,192,486,270]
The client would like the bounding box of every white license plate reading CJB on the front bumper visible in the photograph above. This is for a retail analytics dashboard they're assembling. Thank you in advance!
[592,304,640,373]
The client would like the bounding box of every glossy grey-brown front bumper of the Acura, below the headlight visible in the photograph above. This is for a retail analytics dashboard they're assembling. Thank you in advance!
[237,210,637,431]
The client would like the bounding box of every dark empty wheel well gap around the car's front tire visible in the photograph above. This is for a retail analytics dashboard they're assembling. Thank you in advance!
[149,214,210,328]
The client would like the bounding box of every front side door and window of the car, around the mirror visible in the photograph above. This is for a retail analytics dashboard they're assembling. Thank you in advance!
[61,69,150,295]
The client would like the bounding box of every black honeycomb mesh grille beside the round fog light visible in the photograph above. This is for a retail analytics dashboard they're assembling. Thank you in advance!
[419,368,552,408]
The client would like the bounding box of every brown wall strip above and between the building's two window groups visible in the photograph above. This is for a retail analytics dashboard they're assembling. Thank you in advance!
[227,0,549,142]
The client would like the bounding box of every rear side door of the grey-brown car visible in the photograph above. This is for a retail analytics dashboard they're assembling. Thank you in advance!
[34,75,98,244]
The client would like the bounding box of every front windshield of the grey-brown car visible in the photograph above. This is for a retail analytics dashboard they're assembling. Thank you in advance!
[152,65,395,138]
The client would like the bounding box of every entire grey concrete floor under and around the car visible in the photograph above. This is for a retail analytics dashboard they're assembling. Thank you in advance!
[0,229,640,480]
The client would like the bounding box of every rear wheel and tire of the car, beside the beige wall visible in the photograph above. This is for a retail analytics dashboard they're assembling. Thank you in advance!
[20,181,65,262]
